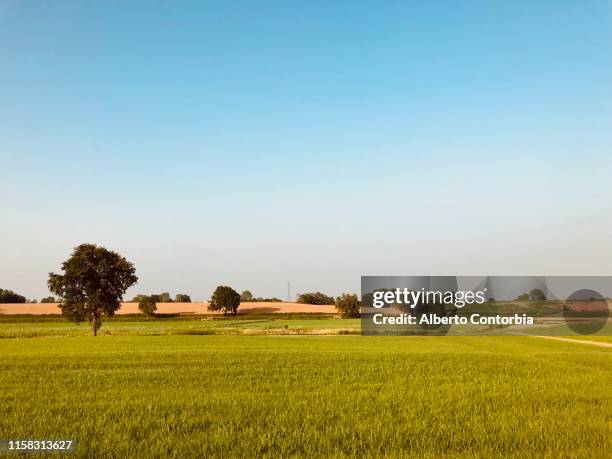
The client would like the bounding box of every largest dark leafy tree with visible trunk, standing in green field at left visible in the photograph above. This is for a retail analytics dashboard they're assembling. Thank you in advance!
[48,244,138,336]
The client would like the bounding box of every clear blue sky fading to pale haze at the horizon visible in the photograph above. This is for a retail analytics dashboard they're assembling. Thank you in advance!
[0,0,612,299]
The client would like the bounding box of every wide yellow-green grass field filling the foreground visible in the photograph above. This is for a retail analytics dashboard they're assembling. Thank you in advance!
[0,319,612,457]
